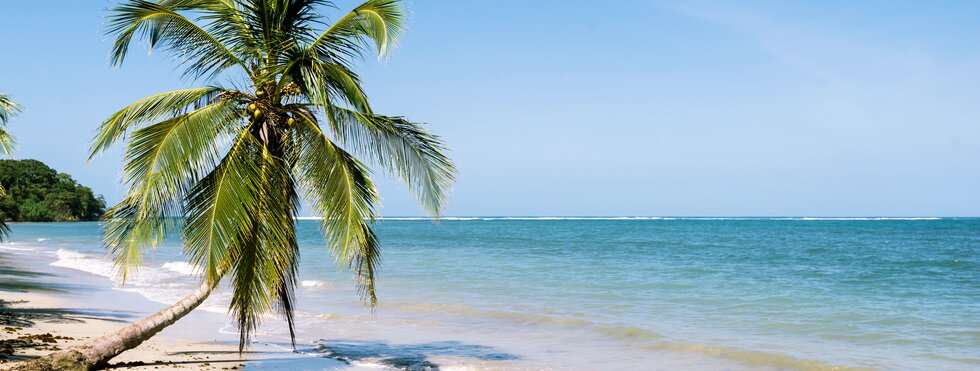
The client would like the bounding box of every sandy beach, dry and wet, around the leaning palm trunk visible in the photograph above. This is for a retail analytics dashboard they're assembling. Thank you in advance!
[0,256,352,370]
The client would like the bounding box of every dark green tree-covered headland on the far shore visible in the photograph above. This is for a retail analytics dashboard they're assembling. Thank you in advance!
[0,160,105,222]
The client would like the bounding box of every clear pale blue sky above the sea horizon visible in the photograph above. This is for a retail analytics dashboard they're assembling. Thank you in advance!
[0,0,980,216]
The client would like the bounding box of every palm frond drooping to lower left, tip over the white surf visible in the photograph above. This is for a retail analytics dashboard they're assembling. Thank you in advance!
[103,100,241,280]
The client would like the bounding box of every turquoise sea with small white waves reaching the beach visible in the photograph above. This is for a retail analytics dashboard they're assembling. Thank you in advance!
[4,218,980,370]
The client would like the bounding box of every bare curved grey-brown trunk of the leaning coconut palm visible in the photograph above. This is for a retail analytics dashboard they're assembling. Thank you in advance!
[13,282,217,371]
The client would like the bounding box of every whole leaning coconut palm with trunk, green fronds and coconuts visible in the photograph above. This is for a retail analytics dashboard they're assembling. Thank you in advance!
[16,0,455,368]
